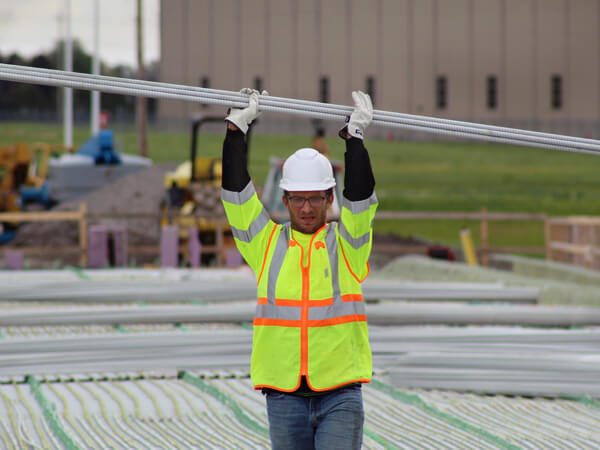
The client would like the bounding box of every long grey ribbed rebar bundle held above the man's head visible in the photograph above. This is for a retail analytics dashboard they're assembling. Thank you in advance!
[0,64,600,155]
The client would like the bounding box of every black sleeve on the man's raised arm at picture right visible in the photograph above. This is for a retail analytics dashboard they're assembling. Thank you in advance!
[344,138,375,202]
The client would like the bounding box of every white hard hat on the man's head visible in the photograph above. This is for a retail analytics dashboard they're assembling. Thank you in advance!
[279,148,335,192]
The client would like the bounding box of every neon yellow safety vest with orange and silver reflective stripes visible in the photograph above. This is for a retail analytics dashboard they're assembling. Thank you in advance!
[222,183,377,392]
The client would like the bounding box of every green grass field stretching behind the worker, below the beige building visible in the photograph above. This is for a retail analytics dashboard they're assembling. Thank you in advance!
[0,123,600,250]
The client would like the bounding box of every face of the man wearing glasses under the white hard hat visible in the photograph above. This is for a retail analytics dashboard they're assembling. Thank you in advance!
[283,191,333,234]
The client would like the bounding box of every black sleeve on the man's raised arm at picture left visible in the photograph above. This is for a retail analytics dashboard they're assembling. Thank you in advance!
[222,129,250,192]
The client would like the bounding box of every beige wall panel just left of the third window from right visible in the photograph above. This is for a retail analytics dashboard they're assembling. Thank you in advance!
[410,0,437,115]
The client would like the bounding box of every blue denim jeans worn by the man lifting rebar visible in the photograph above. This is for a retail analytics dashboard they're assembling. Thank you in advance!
[266,385,365,450]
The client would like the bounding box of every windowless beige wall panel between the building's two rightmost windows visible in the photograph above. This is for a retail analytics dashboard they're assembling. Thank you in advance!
[503,0,537,120]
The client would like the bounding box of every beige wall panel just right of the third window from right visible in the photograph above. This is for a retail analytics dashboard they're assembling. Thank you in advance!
[434,0,472,119]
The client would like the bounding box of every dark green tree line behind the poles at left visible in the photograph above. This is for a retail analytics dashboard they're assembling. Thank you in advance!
[0,40,158,121]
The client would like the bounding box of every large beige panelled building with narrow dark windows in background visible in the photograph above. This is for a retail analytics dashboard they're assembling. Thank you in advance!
[159,0,600,138]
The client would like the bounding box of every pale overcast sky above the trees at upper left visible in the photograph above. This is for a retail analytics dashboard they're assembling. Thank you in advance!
[0,0,160,67]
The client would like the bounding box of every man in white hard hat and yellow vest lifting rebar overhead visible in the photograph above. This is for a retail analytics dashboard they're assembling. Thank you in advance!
[222,90,377,449]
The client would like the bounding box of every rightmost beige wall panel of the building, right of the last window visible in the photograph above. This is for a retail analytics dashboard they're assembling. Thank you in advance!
[566,0,600,119]
